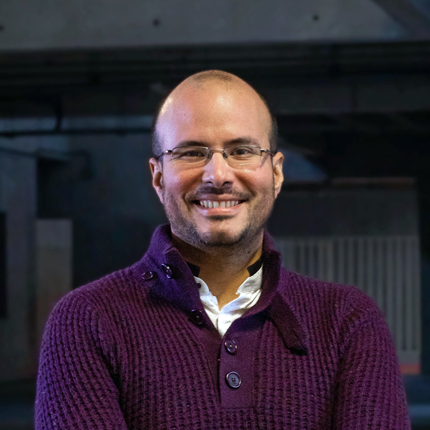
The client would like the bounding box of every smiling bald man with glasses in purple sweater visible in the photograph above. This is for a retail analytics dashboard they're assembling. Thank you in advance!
[36,71,410,430]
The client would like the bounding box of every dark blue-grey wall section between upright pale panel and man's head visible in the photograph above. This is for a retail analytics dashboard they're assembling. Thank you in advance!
[71,134,166,285]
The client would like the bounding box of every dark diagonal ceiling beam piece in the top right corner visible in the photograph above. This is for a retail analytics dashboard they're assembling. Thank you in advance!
[373,0,430,39]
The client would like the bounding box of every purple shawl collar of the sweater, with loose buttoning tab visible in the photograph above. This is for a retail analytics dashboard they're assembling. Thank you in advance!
[133,224,308,354]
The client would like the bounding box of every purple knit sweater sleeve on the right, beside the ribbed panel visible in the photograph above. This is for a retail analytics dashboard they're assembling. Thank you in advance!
[333,289,411,430]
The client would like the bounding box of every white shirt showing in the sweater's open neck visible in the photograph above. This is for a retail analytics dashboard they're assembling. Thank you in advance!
[194,267,263,337]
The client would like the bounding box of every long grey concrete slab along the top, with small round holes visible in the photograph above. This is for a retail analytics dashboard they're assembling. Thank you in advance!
[0,0,405,51]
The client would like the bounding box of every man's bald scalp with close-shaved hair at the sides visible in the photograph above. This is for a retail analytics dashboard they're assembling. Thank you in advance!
[152,70,278,156]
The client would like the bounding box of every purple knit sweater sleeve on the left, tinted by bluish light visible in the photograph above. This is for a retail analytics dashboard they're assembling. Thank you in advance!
[35,290,127,430]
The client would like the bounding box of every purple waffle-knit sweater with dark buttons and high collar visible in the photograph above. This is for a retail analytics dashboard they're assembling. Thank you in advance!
[36,226,410,430]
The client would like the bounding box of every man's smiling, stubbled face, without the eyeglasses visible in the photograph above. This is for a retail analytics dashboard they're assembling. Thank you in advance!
[150,83,283,249]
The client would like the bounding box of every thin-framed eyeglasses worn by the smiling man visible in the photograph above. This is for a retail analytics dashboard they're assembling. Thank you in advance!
[156,145,275,167]
